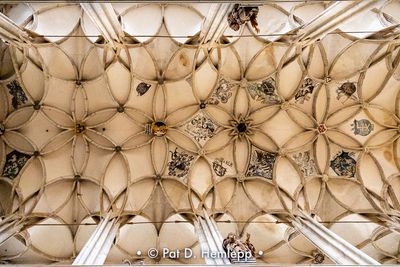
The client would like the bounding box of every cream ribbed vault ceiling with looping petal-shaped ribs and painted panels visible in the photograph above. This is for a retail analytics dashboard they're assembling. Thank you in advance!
[0,1,400,264]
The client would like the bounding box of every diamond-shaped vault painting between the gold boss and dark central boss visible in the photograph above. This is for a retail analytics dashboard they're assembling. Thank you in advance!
[185,113,217,146]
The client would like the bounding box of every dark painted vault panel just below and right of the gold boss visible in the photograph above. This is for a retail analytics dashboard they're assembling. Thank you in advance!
[168,148,194,178]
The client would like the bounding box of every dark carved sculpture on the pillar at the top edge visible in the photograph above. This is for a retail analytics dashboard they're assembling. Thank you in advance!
[228,4,260,32]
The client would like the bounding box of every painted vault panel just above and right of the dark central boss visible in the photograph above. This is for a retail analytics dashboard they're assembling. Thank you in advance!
[247,77,281,104]
